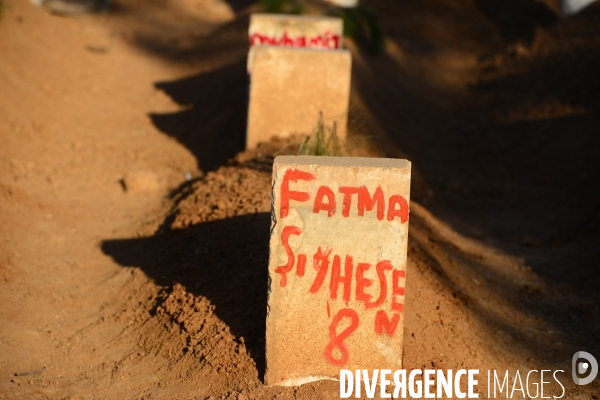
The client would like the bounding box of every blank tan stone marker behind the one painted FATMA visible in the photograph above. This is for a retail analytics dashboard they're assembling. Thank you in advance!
[246,46,352,148]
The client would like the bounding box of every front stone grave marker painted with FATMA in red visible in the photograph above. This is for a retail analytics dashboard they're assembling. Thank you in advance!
[265,156,410,386]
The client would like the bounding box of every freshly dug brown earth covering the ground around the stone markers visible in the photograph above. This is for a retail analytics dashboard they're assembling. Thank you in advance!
[0,0,600,399]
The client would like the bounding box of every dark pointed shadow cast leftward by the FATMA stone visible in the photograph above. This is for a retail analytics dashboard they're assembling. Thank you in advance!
[102,213,270,379]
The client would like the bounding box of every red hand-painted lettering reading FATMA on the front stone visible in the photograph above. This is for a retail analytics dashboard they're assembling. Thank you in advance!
[275,168,409,366]
